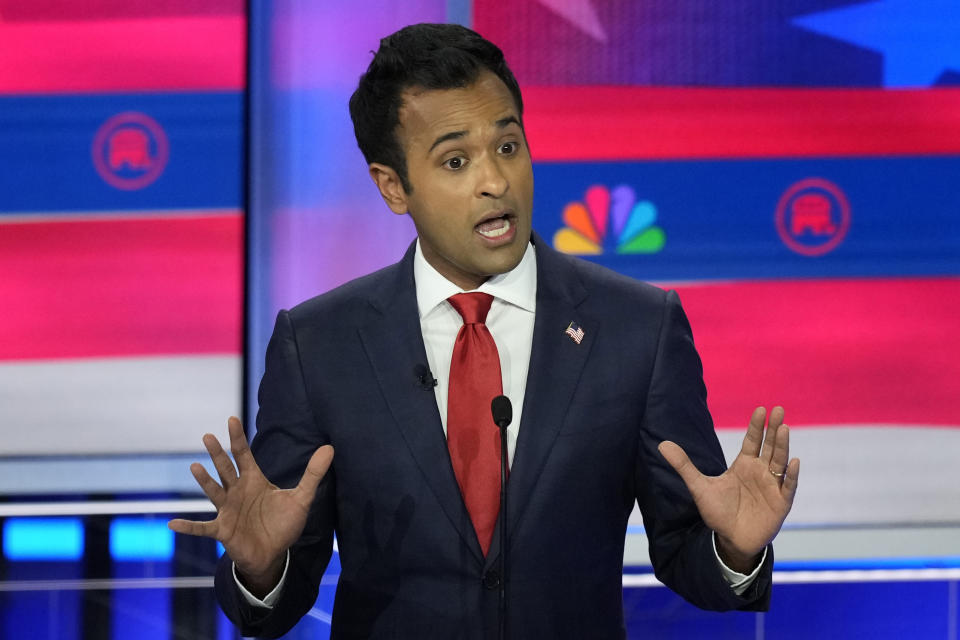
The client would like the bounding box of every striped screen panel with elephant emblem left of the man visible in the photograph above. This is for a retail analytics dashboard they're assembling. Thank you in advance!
[0,0,246,494]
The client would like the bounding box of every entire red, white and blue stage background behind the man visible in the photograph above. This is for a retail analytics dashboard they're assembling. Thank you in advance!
[0,0,960,640]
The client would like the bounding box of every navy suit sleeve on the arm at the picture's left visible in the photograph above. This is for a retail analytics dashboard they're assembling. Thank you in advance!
[215,311,336,638]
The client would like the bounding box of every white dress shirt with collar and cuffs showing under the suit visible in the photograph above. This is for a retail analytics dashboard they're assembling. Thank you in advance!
[233,239,767,607]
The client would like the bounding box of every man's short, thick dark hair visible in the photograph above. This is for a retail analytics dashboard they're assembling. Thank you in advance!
[350,24,523,193]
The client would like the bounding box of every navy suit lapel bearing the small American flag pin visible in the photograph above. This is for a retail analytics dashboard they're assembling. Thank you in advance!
[486,234,600,568]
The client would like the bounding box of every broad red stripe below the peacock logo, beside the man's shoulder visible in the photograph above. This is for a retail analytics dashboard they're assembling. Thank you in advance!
[677,278,960,428]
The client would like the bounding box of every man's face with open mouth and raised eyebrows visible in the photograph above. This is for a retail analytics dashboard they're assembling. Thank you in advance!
[371,72,533,289]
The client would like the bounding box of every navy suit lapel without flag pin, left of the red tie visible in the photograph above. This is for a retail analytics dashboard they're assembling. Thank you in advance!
[358,246,483,561]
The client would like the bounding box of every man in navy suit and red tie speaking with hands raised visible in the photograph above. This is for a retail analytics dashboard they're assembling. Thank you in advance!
[170,25,799,638]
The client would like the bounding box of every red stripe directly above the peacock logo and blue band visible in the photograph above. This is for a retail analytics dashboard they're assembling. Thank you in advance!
[523,87,960,161]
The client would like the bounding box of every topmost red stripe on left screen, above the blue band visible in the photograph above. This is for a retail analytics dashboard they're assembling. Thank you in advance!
[0,15,246,94]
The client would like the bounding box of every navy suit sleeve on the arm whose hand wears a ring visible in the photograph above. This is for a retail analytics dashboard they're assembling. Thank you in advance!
[636,291,773,611]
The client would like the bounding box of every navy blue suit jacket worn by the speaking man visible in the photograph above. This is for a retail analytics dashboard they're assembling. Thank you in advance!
[217,237,772,640]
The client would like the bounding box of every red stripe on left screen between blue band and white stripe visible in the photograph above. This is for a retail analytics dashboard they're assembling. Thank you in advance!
[0,211,243,360]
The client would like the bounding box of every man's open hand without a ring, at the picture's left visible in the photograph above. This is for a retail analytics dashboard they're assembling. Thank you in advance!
[167,417,333,598]
